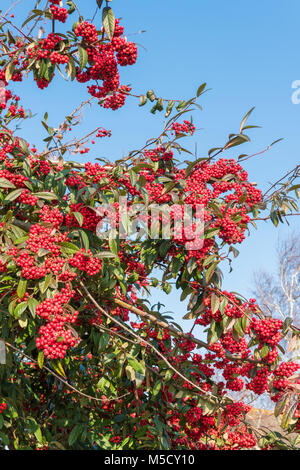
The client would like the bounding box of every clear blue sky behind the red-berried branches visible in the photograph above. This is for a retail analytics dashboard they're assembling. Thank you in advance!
[6,0,300,328]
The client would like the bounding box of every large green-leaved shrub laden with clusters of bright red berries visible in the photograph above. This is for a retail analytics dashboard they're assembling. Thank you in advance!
[0,0,300,449]
